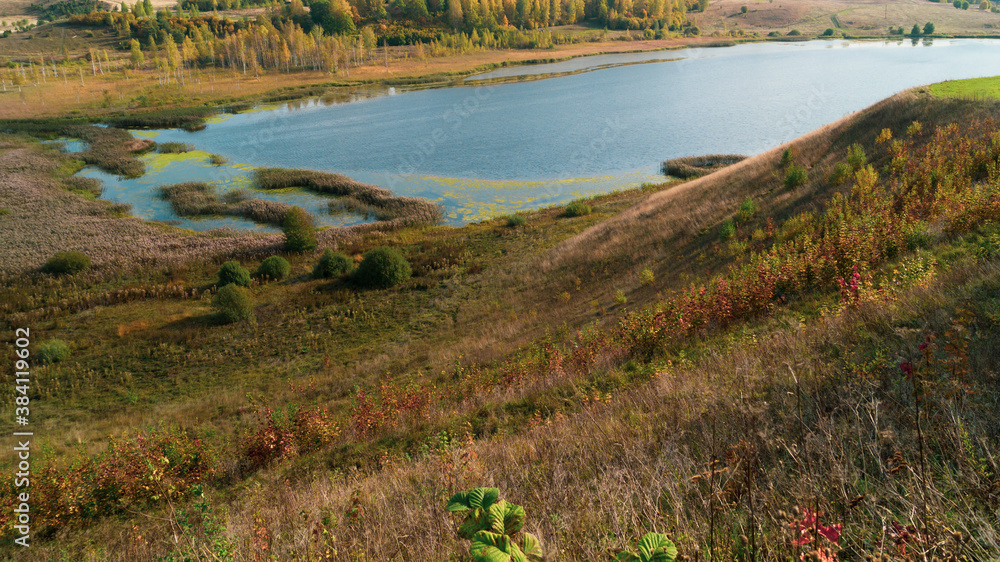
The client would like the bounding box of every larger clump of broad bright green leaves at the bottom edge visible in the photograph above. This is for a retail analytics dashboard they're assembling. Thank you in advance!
[447,488,543,562]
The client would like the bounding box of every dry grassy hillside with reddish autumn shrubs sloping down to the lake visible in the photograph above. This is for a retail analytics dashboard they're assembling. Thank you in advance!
[0,86,1000,561]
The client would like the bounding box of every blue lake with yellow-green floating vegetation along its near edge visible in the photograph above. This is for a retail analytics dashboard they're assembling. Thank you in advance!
[82,39,1000,230]
